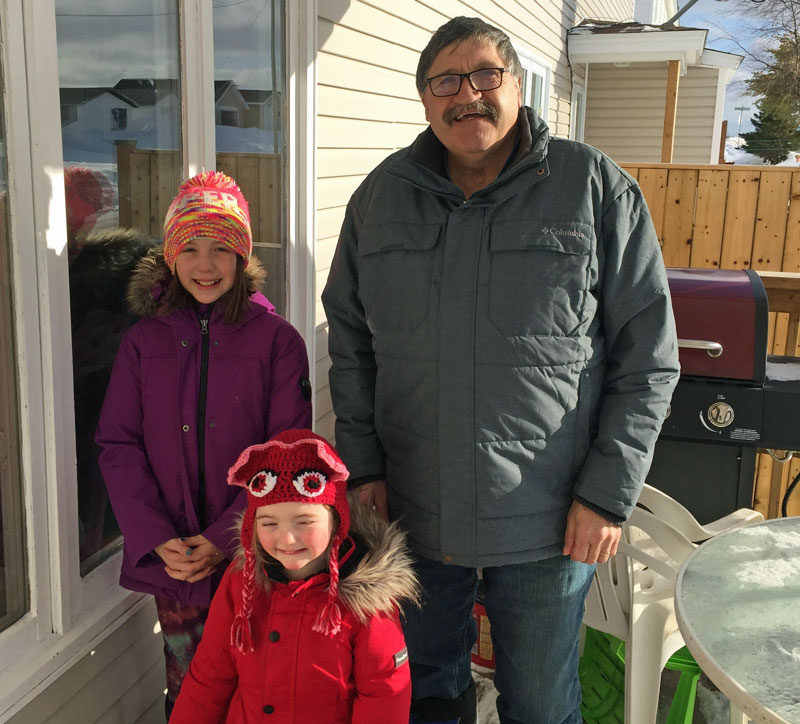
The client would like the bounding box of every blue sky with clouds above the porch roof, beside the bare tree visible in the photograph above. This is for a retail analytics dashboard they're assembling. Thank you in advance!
[678,0,758,136]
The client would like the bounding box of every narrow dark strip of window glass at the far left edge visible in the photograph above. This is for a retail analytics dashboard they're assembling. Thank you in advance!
[0,45,29,631]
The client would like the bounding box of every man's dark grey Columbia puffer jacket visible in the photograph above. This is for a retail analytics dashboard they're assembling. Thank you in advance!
[322,109,678,566]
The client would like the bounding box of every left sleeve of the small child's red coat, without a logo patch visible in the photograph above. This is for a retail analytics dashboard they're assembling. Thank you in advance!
[169,568,239,724]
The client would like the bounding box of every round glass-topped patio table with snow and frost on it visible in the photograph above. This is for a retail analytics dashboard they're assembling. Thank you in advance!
[675,517,800,724]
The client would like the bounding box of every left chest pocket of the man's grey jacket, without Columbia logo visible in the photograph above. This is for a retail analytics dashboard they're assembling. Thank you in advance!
[358,224,441,332]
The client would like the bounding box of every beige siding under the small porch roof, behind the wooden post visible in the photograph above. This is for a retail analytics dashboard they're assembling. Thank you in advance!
[584,63,719,163]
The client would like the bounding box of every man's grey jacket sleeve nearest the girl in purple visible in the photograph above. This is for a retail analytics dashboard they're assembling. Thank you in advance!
[322,199,386,479]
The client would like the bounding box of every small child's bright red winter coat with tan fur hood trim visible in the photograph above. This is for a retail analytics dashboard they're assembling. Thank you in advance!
[170,514,416,724]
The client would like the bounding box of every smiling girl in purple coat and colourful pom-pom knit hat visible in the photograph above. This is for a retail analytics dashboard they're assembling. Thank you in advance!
[96,171,311,718]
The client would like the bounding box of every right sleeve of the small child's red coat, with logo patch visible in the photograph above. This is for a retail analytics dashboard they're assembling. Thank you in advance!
[352,611,411,724]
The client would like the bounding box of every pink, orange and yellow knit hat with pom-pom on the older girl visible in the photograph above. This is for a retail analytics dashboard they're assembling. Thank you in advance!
[164,171,253,272]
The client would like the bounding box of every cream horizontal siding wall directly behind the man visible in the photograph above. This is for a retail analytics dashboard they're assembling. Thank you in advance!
[315,0,633,438]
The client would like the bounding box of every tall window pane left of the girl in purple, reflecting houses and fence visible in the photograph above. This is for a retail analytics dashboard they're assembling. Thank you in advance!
[55,0,181,575]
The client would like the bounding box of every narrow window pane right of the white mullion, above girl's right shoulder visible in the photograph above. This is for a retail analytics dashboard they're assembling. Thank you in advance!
[214,0,286,314]
